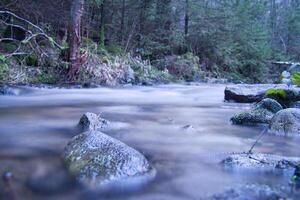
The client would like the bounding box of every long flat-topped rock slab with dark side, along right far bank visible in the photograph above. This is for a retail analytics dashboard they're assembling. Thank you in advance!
[225,84,300,103]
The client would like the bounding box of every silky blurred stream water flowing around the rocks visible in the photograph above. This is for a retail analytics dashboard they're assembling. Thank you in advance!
[0,84,300,200]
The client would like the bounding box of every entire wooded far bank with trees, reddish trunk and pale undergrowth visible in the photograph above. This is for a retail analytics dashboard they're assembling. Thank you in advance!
[0,0,300,85]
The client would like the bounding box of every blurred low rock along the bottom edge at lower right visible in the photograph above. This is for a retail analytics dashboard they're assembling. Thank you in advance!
[206,184,300,200]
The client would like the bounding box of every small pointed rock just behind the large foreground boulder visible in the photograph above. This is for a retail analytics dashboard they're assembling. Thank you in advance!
[78,112,110,131]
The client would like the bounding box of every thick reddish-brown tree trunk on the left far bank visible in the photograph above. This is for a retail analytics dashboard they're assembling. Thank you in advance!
[68,0,84,81]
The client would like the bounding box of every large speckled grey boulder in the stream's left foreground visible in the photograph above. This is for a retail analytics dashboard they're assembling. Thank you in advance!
[64,131,152,187]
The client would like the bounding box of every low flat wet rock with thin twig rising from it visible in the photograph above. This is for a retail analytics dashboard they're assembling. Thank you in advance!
[222,153,300,170]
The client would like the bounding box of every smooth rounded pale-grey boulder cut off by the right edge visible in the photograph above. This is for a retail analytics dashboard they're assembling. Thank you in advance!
[269,108,300,135]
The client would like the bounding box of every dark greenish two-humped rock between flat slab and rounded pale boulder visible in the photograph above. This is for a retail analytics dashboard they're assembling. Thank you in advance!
[231,98,282,125]
